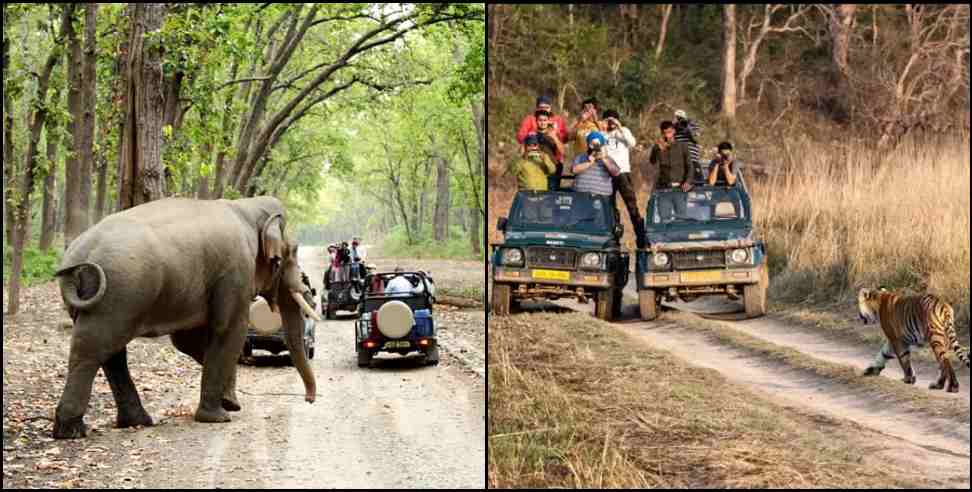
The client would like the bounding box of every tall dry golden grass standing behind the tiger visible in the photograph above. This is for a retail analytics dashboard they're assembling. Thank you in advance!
[750,139,970,327]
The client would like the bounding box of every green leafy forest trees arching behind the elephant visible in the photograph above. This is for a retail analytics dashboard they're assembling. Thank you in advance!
[3,3,486,314]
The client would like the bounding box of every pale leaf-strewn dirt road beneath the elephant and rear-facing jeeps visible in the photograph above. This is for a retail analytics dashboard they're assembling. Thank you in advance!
[4,247,486,489]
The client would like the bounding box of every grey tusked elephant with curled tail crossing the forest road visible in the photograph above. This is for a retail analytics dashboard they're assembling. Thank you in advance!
[53,197,320,439]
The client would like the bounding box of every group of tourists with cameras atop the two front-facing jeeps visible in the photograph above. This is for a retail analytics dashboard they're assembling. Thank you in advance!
[510,95,741,248]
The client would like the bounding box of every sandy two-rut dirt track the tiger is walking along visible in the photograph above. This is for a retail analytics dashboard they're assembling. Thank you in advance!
[525,289,970,489]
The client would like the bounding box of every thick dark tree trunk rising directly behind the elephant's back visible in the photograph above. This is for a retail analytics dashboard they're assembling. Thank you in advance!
[118,3,165,210]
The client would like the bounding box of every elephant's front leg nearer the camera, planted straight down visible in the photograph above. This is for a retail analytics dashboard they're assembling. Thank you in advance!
[196,281,249,422]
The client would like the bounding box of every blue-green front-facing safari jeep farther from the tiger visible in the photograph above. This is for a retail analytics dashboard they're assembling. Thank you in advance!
[492,191,630,320]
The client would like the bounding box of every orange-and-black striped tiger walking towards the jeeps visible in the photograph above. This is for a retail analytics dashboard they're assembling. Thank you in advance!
[857,289,969,393]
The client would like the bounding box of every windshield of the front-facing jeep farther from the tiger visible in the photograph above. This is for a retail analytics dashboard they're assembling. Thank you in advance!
[509,192,614,235]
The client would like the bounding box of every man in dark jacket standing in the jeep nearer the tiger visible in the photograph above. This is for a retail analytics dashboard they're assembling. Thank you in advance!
[648,121,692,221]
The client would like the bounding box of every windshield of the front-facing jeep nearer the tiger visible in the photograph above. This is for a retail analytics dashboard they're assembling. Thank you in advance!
[649,187,749,227]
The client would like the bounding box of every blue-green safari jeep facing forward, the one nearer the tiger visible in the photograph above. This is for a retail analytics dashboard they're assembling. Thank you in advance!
[636,179,769,321]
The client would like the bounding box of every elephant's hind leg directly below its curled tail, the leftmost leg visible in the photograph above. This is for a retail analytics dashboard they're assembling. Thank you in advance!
[54,314,131,439]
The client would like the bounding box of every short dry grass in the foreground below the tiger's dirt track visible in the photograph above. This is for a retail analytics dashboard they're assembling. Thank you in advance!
[488,314,932,488]
